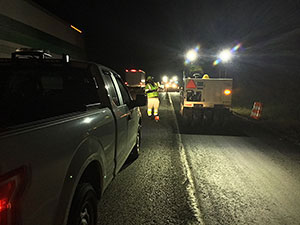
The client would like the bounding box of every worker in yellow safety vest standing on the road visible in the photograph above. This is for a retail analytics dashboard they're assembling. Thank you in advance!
[145,76,159,121]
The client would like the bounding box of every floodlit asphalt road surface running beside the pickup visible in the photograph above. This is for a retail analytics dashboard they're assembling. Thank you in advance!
[99,93,300,225]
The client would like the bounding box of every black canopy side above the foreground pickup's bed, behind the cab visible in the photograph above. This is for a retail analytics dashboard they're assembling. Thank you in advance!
[0,65,100,129]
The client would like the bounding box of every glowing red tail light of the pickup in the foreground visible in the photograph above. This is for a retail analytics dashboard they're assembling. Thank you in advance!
[0,167,25,225]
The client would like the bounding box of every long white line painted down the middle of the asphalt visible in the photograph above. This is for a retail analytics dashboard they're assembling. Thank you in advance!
[168,93,205,225]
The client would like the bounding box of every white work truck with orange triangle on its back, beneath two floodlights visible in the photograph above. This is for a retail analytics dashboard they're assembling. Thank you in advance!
[180,73,232,124]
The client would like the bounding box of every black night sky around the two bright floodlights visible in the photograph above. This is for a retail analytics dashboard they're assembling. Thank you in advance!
[35,0,300,79]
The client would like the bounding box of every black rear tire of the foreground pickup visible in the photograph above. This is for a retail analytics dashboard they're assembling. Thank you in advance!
[68,183,98,225]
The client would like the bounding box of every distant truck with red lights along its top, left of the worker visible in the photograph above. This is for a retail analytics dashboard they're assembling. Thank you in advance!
[125,69,146,99]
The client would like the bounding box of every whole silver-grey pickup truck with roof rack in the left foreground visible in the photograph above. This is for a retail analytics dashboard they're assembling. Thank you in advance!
[0,50,146,225]
